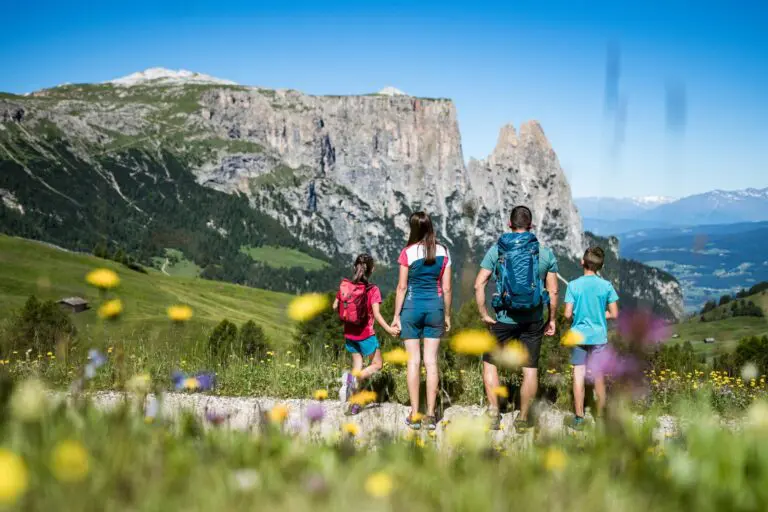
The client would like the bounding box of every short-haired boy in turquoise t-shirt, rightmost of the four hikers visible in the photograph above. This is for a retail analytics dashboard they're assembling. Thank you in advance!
[565,247,619,430]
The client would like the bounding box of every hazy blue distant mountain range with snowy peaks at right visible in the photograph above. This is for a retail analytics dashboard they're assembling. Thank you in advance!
[575,188,768,236]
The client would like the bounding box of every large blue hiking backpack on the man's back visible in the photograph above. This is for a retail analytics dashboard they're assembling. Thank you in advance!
[492,232,546,311]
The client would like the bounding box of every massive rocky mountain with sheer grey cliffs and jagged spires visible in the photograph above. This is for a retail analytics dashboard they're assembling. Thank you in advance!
[0,69,679,312]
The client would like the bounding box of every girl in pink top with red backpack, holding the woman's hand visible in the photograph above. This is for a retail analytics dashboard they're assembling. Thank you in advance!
[333,254,399,414]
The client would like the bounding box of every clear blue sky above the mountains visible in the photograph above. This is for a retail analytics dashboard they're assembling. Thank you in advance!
[0,0,768,197]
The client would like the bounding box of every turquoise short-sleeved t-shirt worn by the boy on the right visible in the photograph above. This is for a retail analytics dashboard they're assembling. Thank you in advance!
[565,275,619,345]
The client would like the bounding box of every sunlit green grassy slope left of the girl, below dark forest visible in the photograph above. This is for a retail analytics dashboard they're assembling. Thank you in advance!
[0,235,291,338]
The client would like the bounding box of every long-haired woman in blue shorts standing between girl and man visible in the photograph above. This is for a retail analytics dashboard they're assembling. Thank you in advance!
[392,212,451,430]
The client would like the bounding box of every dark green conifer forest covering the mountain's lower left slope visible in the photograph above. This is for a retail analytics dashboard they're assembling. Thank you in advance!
[0,140,346,293]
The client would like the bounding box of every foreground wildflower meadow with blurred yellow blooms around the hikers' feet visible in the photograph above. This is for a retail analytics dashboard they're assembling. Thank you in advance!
[0,269,768,511]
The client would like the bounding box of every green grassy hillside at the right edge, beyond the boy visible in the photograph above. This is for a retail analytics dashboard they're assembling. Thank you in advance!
[672,291,768,355]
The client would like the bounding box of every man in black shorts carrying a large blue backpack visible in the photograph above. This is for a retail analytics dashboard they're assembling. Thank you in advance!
[475,206,558,431]
